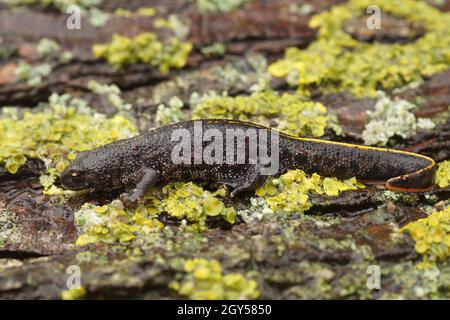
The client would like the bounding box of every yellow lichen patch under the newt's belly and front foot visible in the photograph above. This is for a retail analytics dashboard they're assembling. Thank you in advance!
[75,182,236,246]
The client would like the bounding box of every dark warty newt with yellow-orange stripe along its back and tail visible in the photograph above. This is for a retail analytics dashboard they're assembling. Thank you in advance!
[61,120,436,206]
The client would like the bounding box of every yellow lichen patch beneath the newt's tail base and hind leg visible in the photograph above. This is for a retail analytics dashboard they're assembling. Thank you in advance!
[256,170,364,213]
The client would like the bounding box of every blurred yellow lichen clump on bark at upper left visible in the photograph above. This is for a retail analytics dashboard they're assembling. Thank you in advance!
[92,32,192,73]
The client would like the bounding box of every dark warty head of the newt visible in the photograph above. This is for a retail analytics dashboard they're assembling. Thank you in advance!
[61,149,120,190]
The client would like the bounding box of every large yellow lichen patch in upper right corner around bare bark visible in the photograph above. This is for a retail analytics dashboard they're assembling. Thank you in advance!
[269,0,450,96]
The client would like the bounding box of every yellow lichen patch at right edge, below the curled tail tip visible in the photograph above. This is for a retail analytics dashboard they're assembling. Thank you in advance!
[401,208,450,269]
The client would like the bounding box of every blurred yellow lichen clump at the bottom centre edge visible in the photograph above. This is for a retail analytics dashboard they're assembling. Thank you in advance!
[169,258,260,300]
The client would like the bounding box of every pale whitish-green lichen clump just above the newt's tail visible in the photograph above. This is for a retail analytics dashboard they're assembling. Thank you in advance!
[362,92,435,146]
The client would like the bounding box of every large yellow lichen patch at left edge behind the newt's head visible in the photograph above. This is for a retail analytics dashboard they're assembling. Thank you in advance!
[0,94,136,188]
